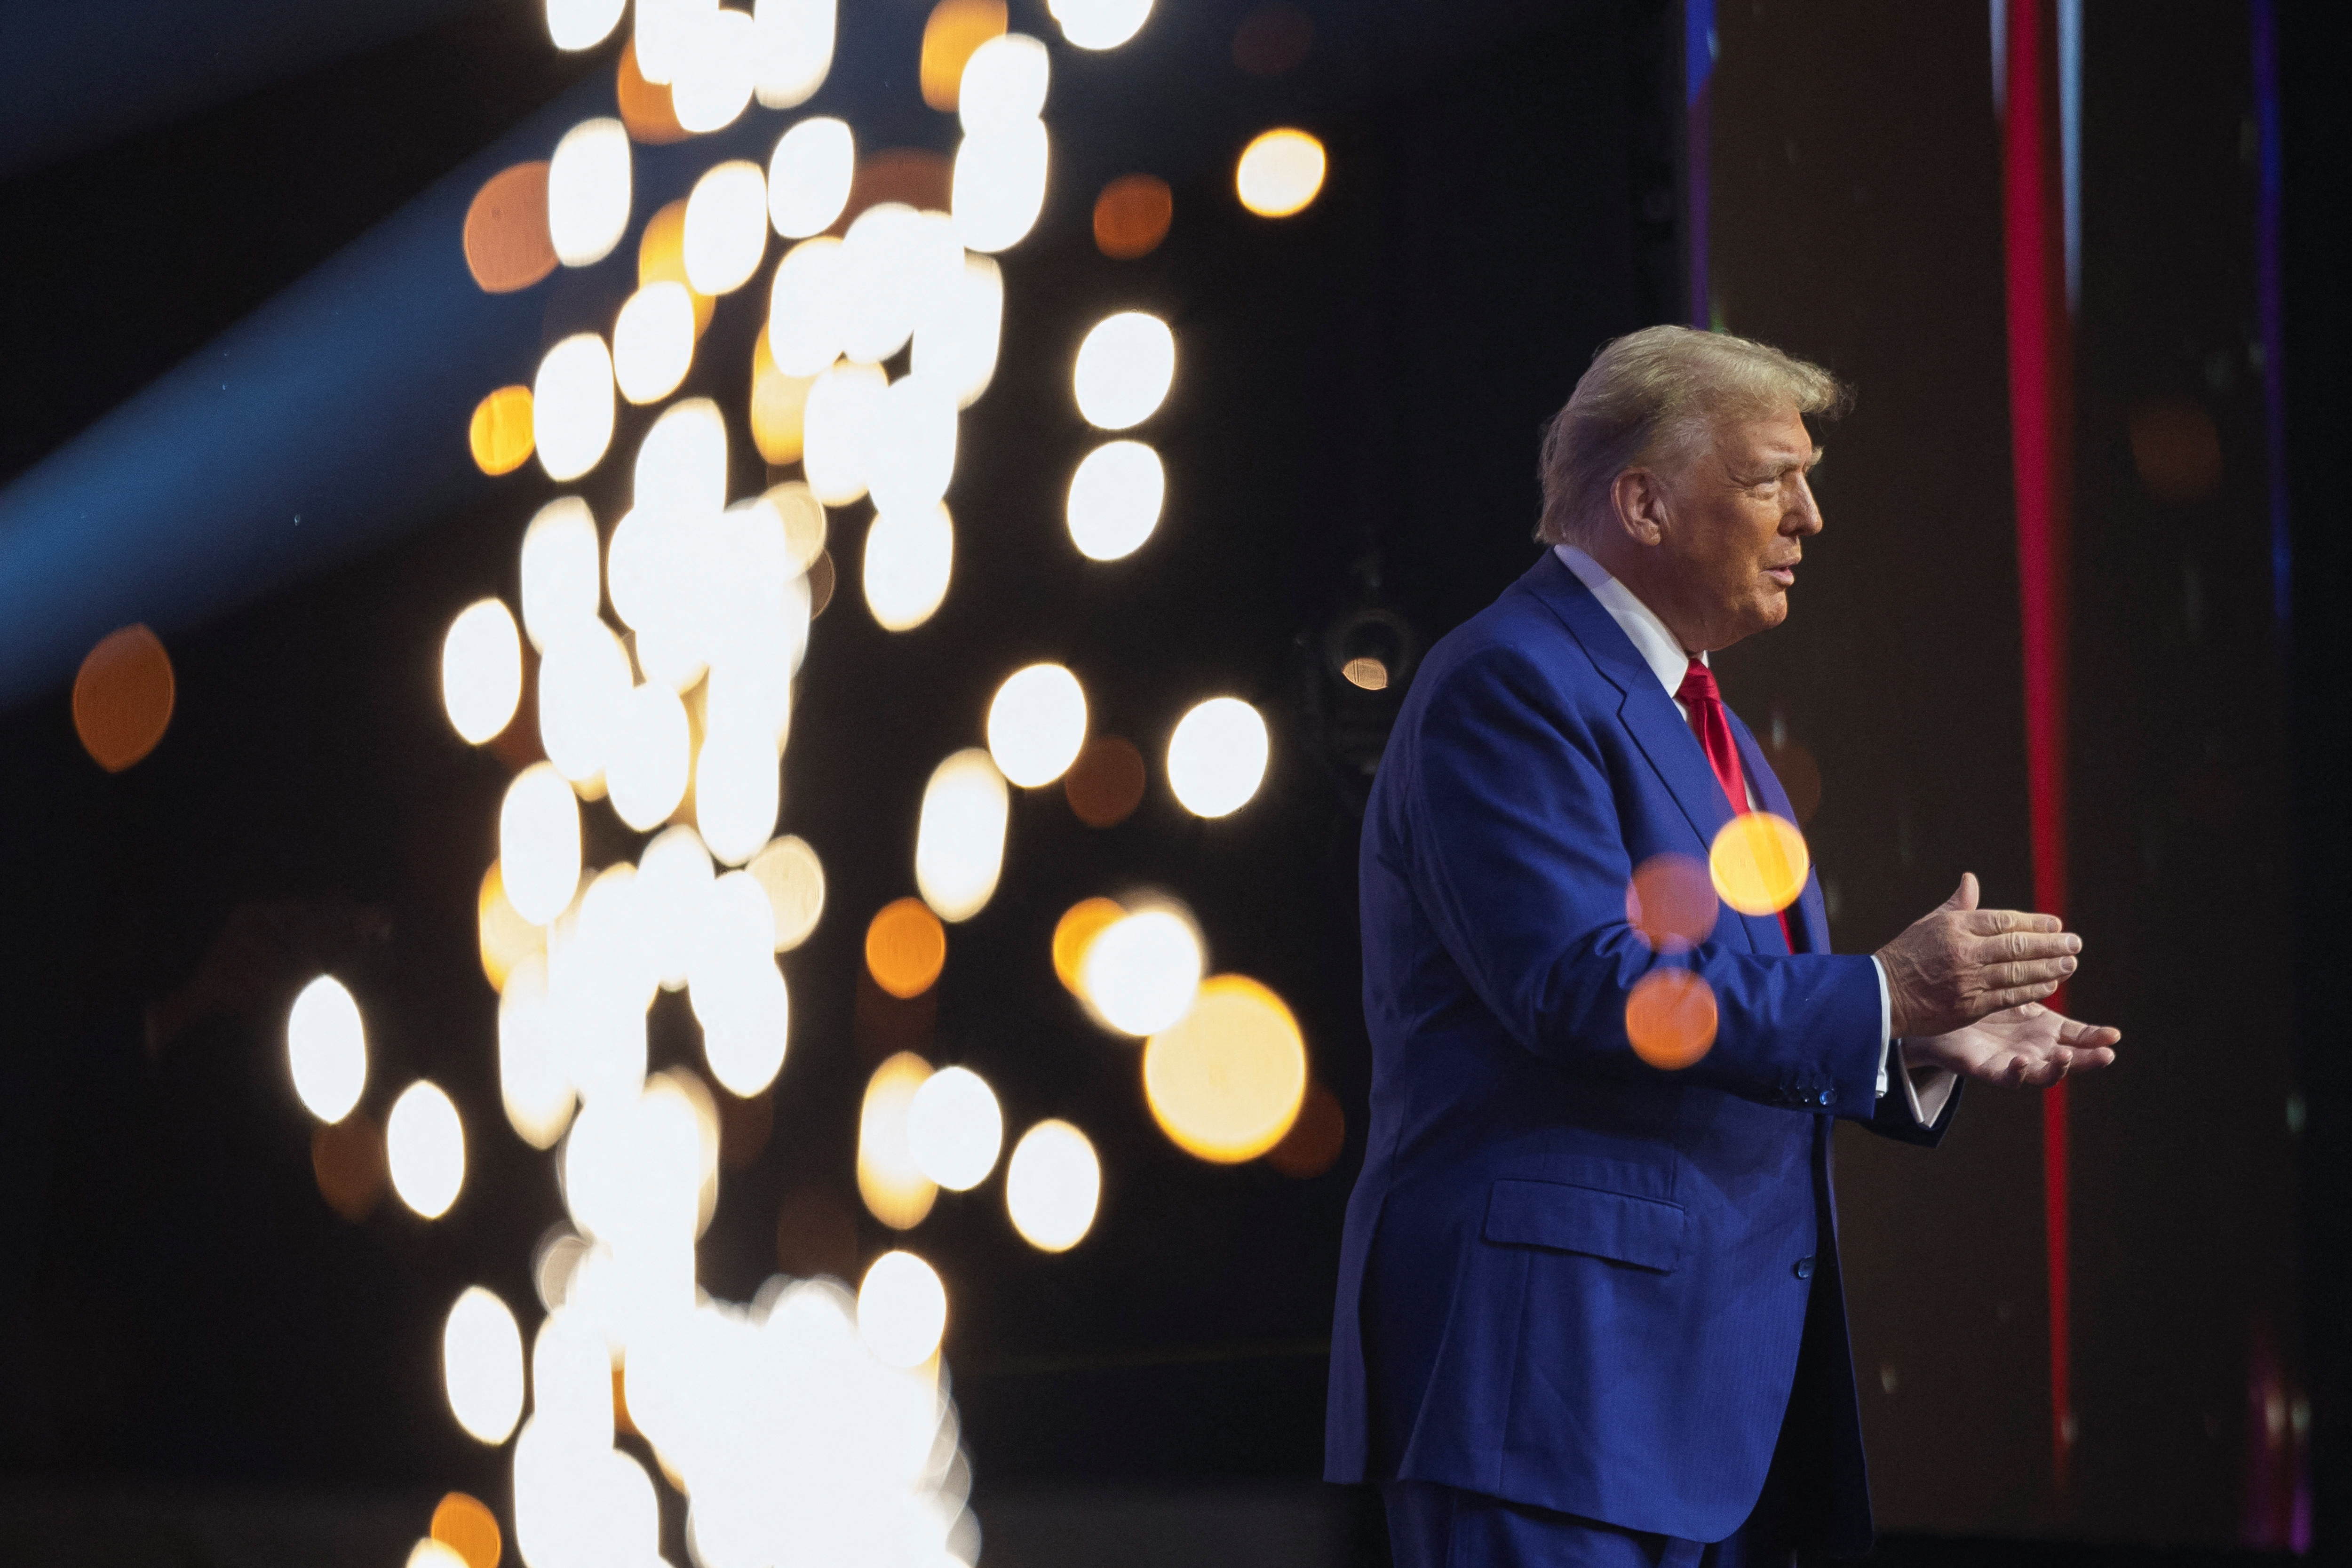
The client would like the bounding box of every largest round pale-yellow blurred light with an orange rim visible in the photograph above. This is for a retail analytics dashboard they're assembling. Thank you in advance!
[1143,982,1308,1166]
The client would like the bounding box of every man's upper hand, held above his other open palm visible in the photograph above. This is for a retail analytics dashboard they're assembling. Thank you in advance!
[1879,872,2082,1039]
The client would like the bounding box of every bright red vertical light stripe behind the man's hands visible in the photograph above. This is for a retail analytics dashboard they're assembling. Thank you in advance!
[2002,0,2074,1493]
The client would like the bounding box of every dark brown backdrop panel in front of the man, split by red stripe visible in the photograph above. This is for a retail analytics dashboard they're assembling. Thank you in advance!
[1710,0,2303,1542]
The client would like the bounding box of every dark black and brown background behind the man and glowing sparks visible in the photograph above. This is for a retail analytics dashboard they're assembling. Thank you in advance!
[0,0,2352,1542]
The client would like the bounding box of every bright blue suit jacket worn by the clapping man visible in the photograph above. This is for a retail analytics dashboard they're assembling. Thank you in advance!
[1327,552,1957,1552]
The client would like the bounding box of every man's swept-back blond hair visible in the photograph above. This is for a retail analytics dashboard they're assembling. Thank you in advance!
[1536,327,1853,545]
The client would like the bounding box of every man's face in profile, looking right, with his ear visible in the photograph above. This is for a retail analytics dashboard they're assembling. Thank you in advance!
[1658,409,1820,651]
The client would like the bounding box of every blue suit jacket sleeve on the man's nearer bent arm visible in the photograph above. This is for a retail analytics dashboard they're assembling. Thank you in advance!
[1395,646,1879,1122]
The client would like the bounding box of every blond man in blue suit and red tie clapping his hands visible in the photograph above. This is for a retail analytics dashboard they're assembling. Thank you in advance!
[1327,327,2119,1568]
